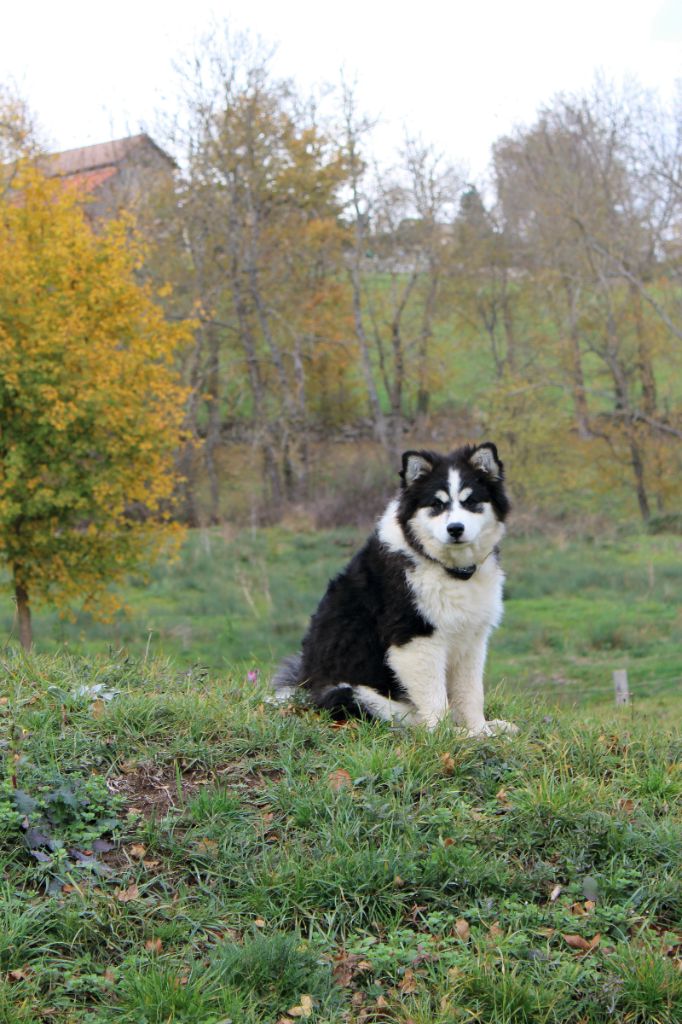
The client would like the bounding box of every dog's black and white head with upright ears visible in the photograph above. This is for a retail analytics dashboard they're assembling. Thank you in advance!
[398,441,509,567]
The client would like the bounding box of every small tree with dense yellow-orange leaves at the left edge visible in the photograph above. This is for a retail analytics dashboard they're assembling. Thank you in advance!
[0,164,190,647]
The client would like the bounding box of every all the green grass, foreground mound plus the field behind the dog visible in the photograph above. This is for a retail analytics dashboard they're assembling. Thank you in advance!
[0,529,682,1024]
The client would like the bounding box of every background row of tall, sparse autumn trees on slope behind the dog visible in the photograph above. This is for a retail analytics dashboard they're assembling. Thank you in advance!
[3,35,682,524]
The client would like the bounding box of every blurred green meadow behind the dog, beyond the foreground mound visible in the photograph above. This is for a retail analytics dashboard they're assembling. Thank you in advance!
[0,528,682,707]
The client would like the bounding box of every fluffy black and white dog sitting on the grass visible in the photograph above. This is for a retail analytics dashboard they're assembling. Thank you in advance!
[272,442,516,735]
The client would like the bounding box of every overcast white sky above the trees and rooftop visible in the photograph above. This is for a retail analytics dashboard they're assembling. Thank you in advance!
[0,0,682,175]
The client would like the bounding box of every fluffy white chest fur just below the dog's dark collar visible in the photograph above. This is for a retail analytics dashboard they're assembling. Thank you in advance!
[407,559,505,639]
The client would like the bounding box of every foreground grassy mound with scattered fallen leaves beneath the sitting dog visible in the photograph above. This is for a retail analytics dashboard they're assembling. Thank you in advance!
[0,651,682,1024]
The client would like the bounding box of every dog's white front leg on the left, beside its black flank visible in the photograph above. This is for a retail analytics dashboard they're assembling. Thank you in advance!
[386,637,447,729]
